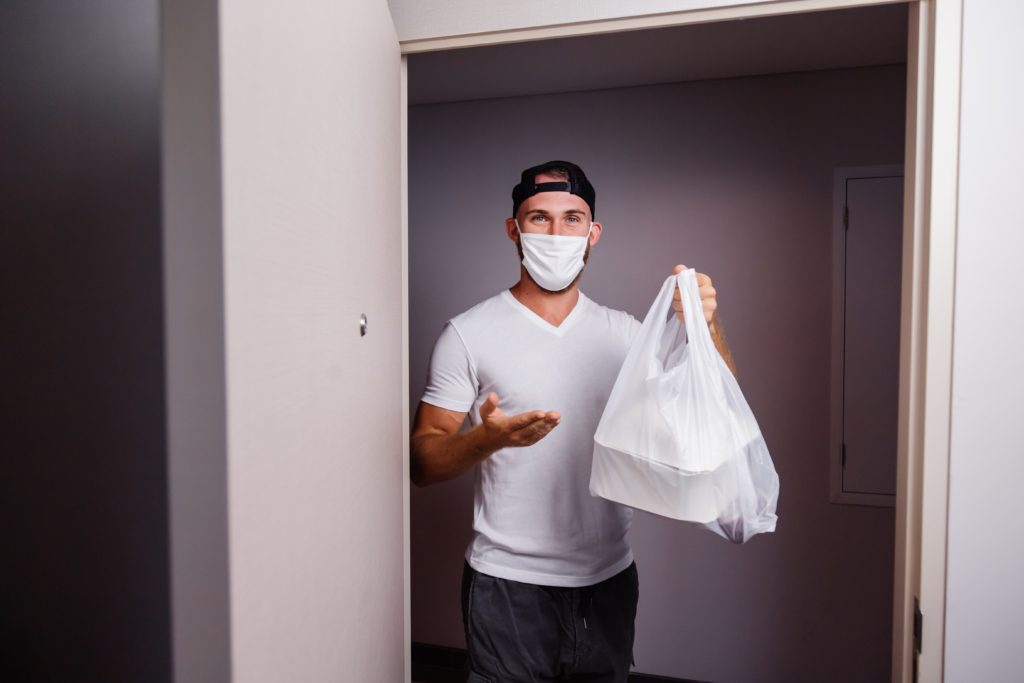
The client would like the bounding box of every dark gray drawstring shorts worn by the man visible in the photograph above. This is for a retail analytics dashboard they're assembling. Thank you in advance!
[462,562,639,683]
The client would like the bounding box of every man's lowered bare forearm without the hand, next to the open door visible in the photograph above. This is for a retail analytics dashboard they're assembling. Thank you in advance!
[410,425,498,486]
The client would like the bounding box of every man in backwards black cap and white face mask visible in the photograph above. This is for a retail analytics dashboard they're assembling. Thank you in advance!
[411,161,732,683]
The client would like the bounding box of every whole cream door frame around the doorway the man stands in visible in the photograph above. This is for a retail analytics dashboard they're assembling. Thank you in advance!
[399,0,963,683]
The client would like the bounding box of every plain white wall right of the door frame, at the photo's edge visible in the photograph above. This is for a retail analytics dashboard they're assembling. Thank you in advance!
[942,0,1024,683]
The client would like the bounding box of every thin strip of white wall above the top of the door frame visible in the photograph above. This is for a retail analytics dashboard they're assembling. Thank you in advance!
[388,0,811,40]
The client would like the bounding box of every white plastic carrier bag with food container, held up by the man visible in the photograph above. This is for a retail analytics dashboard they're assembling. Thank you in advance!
[590,269,778,543]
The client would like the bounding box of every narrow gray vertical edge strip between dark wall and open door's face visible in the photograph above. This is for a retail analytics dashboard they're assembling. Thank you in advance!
[160,0,232,683]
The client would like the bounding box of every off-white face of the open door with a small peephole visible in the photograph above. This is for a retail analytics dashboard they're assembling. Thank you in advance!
[220,0,407,683]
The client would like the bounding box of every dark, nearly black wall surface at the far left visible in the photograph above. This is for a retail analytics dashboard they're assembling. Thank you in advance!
[0,0,170,683]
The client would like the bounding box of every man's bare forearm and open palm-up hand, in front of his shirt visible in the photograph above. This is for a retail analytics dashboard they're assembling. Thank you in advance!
[410,392,562,486]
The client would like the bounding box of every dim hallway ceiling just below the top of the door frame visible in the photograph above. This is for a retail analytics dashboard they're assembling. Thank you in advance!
[409,3,907,104]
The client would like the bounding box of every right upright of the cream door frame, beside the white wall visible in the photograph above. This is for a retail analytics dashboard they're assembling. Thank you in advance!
[893,0,963,683]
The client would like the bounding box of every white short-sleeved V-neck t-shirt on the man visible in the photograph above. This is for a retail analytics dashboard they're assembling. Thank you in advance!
[423,291,640,587]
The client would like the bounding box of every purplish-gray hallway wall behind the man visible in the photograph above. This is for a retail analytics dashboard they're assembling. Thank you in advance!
[409,67,905,683]
